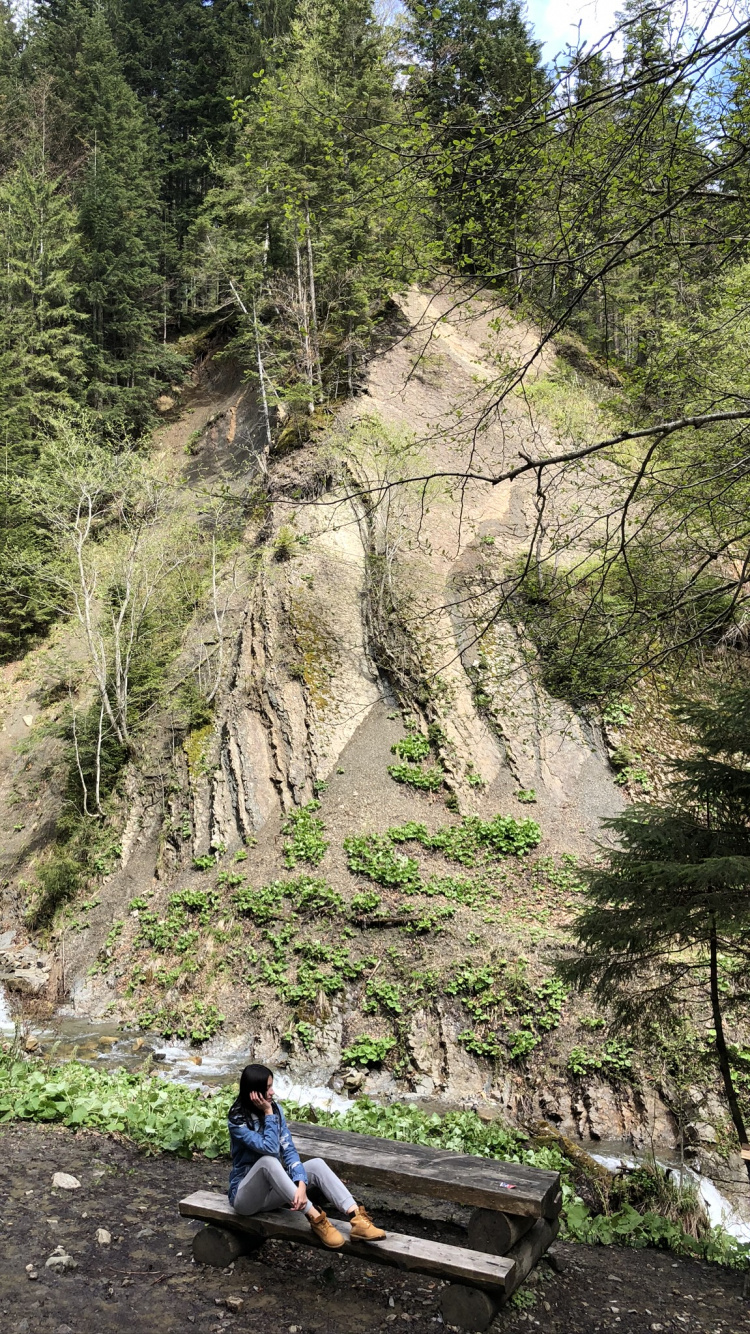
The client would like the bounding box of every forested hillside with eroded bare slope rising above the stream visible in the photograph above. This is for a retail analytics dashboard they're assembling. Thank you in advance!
[0,0,750,1227]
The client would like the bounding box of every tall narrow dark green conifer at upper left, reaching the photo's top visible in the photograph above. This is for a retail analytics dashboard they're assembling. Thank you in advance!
[39,5,177,430]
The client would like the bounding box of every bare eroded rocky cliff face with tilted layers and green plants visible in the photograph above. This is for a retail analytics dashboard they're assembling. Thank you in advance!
[0,291,736,1195]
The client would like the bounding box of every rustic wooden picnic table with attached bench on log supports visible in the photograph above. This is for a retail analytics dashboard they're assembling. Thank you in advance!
[179,1122,562,1330]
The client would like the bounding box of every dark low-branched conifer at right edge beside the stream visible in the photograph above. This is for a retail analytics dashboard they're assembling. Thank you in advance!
[562,686,750,1175]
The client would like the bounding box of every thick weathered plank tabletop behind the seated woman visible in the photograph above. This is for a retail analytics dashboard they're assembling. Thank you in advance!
[290,1121,560,1218]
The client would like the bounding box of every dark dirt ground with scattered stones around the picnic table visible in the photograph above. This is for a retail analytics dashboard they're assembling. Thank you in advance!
[0,1125,750,1334]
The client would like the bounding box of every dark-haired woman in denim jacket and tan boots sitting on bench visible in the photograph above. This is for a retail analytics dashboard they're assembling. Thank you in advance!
[228,1066,386,1250]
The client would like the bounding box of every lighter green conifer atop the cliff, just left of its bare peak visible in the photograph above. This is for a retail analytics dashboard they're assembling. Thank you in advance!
[200,0,419,411]
